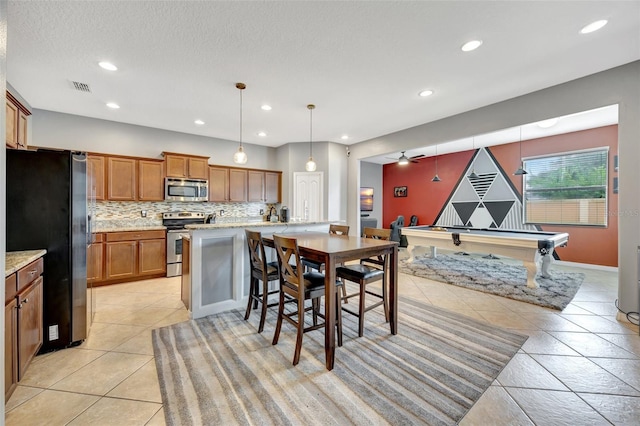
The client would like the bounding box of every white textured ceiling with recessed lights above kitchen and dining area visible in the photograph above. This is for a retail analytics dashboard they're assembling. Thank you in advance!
[7,1,640,149]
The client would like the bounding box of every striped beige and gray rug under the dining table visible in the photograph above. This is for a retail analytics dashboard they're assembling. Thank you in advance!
[152,300,527,425]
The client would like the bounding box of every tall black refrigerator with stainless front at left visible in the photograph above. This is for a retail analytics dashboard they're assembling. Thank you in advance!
[6,149,90,352]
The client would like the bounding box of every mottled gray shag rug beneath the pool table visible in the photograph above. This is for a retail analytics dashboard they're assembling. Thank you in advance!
[399,253,584,310]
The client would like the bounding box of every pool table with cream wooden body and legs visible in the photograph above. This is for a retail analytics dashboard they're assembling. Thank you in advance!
[401,226,569,288]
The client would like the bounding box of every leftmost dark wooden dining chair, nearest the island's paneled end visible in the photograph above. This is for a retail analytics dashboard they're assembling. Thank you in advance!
[244,229,280,333]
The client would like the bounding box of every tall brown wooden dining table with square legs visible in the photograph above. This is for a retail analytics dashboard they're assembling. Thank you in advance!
[262,232,398,370]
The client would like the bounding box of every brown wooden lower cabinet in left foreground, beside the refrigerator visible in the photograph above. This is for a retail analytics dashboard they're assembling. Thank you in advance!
[4,258,44,402]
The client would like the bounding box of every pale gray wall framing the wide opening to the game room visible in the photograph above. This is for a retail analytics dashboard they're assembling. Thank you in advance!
[348,61,640,318]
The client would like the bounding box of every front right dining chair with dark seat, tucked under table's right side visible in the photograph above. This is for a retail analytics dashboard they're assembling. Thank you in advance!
[336,228,391,337]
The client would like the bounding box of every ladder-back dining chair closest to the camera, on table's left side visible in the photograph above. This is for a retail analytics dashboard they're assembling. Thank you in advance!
[272,235,342,365]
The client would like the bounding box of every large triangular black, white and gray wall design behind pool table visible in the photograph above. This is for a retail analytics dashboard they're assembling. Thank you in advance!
[435,148,537,230]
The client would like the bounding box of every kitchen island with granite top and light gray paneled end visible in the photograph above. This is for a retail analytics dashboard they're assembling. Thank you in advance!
[183,222,329,319]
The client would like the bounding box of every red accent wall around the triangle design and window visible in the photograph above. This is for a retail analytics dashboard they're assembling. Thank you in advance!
[382,125,618,266]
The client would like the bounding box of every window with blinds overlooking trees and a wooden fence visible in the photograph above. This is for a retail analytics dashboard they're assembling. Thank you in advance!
[523,148,609,226]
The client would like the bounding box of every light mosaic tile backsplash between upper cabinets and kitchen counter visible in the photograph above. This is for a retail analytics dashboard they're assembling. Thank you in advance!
[95,201,275,225]
